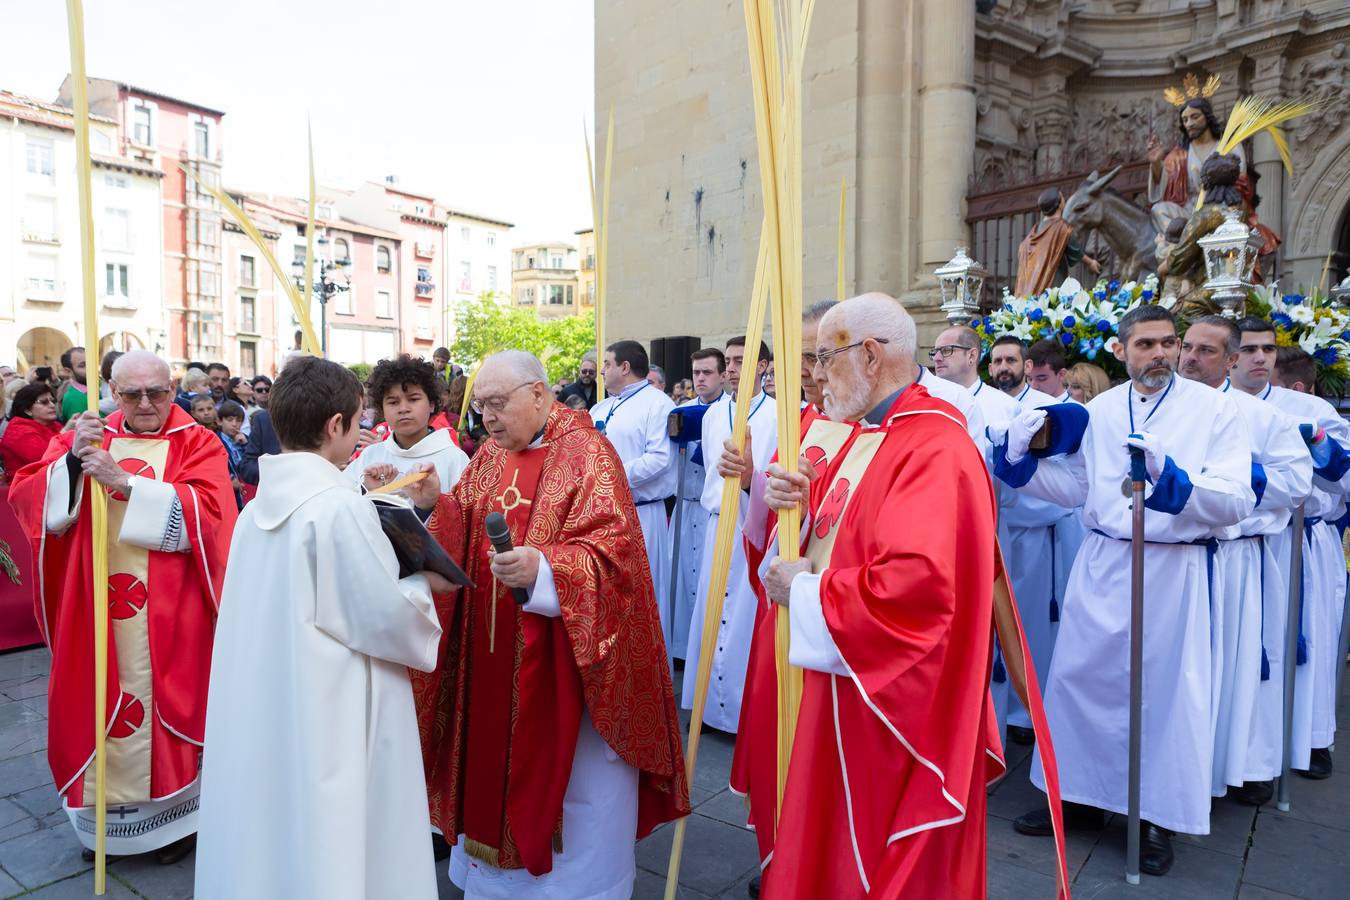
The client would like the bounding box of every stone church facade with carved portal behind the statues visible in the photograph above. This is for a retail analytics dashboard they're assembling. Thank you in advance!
[593,0,1350,343]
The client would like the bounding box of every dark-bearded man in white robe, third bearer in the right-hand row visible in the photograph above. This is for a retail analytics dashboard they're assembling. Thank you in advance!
[1233,317,1350,779]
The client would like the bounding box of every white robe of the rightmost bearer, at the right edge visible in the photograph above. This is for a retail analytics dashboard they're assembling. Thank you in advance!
[1257,385,1350,769]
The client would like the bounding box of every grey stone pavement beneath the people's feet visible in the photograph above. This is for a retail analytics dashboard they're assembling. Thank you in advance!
[0,650,1350,900]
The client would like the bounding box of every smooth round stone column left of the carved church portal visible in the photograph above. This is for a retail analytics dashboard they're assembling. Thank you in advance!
[914,3,975,275]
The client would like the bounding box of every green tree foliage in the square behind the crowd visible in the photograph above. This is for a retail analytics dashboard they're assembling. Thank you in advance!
[450,291,595,383]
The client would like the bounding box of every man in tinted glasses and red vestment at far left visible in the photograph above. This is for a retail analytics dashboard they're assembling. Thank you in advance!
[9,351,238,864]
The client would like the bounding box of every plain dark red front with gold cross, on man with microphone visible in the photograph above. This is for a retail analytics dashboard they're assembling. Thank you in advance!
[462,447,582,873]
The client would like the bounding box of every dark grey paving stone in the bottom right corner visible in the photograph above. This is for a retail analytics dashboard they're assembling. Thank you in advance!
[1242,812,1350,900]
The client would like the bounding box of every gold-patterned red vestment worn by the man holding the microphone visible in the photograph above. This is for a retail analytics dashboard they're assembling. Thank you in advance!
[412,403,690,876]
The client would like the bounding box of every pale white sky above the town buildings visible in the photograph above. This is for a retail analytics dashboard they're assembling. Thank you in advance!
[0,0,594,246]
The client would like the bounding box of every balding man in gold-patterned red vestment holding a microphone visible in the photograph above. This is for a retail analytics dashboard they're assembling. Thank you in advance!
[408,351,690,897]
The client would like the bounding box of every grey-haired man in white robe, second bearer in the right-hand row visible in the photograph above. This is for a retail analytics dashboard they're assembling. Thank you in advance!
[1181,316,1312,806]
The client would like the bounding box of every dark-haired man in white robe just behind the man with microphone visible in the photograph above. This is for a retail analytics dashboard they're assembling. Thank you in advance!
[591,340,676,644]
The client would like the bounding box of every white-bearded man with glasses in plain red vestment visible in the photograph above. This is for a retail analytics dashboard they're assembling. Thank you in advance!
[756,294,1067,900]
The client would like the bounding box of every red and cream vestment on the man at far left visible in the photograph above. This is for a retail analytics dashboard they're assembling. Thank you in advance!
[9,406,238,807]
